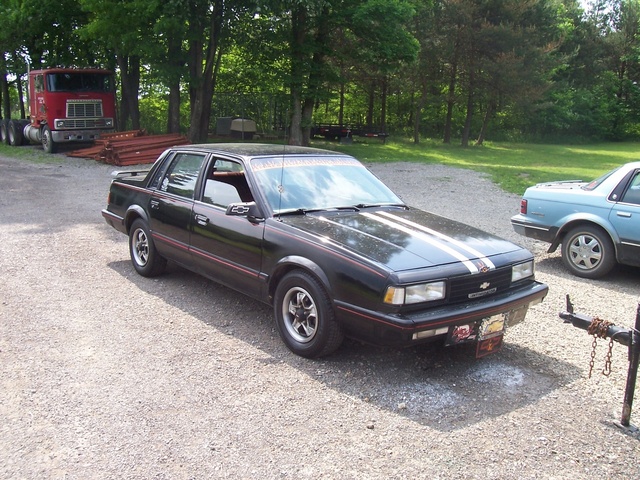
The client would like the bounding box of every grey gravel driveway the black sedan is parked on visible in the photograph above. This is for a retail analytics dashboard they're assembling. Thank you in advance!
[0,149,640,480]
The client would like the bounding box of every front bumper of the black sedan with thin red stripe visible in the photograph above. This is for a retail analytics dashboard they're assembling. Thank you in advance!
[336,282,549,346]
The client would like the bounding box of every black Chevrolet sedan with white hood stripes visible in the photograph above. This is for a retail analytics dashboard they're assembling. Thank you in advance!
[102,144,548,358]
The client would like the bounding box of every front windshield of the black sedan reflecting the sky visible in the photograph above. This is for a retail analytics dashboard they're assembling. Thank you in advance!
[252,156,403,214]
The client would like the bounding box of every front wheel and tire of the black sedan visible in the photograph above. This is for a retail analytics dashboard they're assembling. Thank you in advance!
[273,270,344,358]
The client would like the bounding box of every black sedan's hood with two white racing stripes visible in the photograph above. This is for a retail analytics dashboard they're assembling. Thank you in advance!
[283,208,523,273]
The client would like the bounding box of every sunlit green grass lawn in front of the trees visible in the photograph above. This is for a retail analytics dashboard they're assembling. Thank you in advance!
[314,140,640,195]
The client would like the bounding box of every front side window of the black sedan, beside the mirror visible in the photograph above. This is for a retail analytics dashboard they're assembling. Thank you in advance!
[202,159,253,208]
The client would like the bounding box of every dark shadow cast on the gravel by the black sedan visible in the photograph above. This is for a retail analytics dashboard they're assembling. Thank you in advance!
[109,261,580,434]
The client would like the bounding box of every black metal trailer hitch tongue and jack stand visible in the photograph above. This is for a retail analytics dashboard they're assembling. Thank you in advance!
[560,295,640,430]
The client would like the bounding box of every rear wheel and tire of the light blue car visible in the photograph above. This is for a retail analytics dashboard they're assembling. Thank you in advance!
[562,225,616,278]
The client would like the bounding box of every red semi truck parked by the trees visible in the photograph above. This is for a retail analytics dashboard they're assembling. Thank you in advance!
[0,68,116,153]
